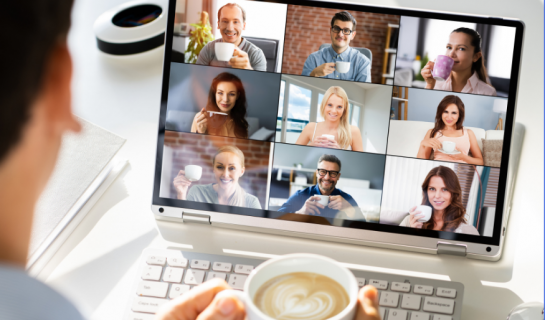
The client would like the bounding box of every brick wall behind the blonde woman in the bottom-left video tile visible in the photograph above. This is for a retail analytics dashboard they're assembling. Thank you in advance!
[165,131,271,208]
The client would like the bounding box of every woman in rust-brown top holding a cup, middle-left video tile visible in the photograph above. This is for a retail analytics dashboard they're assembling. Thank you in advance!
[191,72,248,139]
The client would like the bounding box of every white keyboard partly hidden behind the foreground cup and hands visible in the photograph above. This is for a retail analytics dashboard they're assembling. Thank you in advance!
[124,249,464,320]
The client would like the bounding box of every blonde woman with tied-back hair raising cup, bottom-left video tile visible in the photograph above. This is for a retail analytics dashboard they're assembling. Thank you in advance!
[173,146,261,209]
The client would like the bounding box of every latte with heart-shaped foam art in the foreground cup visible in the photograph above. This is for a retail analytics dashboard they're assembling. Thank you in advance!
[254,272,350,320]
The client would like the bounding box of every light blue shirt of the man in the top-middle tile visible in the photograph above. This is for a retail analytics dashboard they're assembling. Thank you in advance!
[302,46,371,82]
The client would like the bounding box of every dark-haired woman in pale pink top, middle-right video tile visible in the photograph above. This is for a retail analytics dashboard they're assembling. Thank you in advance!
[416,95,484,165]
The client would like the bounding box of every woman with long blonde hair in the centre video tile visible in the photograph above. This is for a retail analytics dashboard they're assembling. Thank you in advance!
[295,87,363,151]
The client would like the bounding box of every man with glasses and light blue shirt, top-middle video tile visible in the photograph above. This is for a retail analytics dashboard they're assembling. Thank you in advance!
[302,11,371,82]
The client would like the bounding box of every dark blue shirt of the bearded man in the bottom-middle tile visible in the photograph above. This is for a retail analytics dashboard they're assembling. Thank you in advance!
[278,185,363,218]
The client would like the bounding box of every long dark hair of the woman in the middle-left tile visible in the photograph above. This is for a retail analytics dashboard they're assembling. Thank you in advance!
[206,72,248,138]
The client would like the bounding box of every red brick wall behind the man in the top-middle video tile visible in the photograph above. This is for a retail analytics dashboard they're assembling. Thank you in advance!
[282,5,399,83]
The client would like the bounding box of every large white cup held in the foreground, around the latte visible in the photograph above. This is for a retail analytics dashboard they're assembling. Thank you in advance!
[216,253,359,320]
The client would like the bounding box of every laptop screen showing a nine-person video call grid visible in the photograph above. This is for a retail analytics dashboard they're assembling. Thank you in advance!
[153,0,522,245]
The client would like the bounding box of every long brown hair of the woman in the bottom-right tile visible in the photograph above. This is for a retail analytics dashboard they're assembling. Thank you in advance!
[422,166,466,231]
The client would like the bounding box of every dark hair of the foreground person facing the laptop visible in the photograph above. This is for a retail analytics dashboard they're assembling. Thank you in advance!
[0,0,72,162]
